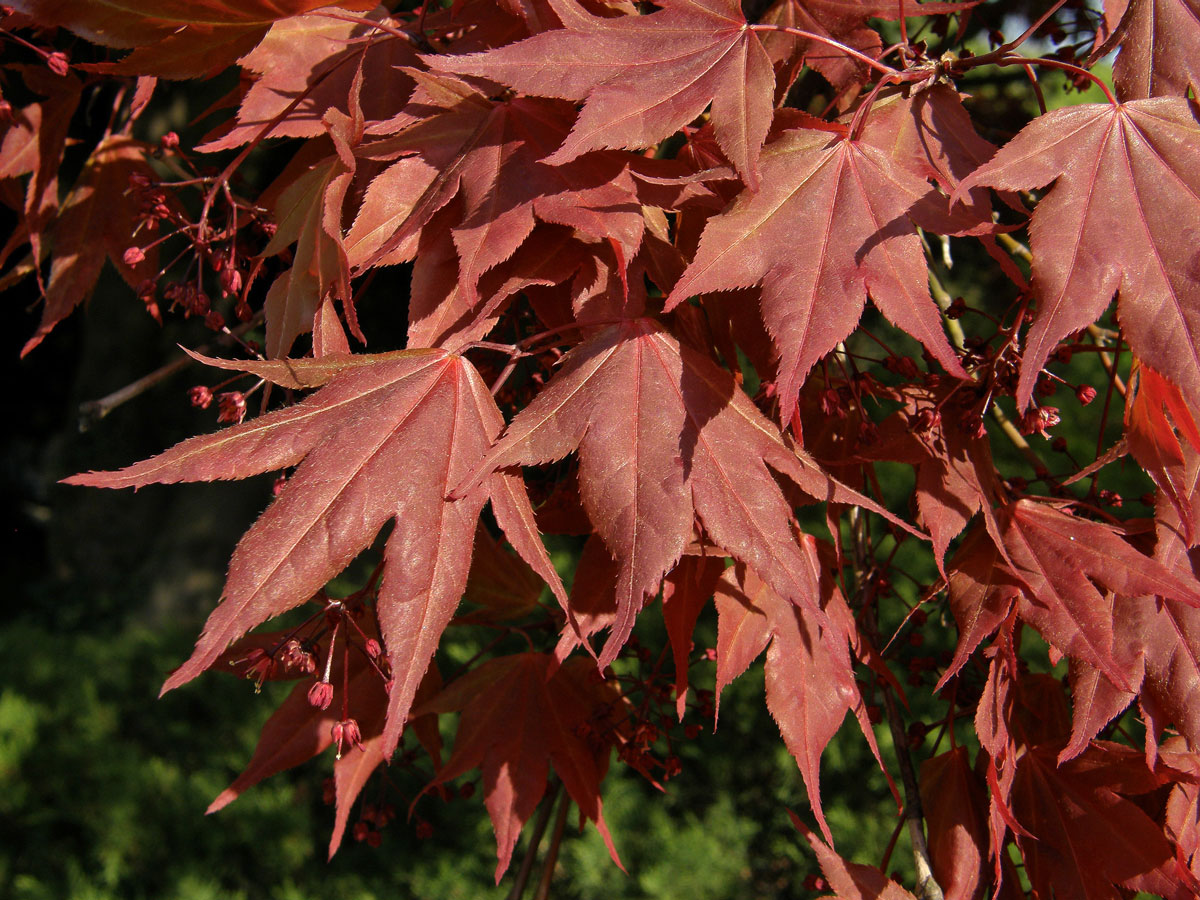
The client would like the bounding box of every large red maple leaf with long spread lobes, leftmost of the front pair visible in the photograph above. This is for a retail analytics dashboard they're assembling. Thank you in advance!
[66,350,565,755]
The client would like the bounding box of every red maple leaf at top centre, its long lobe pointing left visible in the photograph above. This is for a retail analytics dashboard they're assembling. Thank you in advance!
[425,0,774,190]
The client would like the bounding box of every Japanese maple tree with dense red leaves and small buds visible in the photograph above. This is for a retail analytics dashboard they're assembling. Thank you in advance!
[0,0,1200,900]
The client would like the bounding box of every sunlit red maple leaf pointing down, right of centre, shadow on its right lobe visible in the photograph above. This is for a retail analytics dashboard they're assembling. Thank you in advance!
[667,120,966,424]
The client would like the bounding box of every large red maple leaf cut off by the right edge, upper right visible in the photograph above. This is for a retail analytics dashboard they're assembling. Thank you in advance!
[959,97,1200,407]
